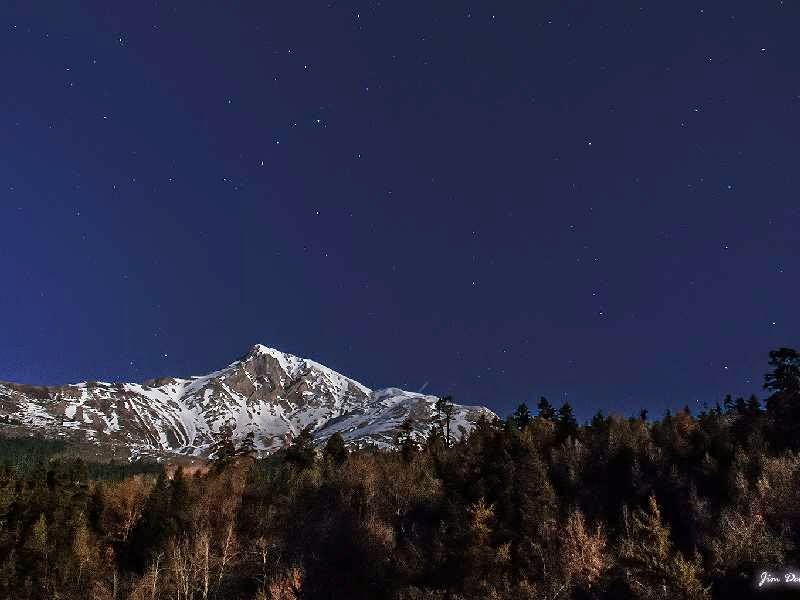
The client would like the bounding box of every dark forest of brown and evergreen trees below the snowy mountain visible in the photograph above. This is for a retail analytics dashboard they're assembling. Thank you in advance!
[0,348,800,600]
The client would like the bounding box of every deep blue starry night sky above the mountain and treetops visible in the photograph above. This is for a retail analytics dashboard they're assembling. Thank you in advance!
[0,0,800,419]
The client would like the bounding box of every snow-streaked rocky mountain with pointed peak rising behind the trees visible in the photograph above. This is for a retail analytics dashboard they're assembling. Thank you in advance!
[0,345,495,457]
